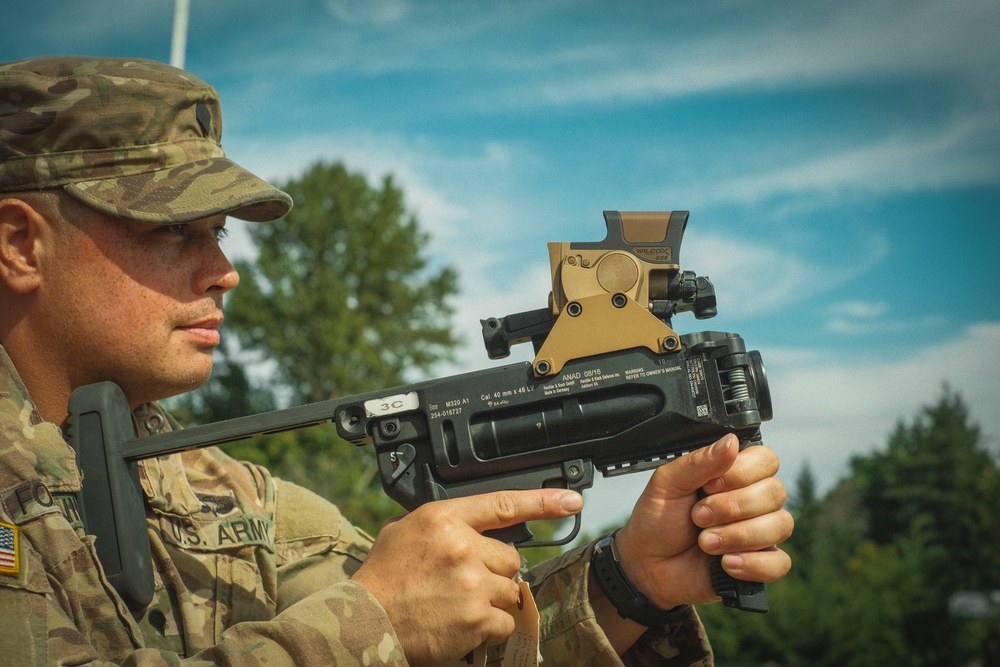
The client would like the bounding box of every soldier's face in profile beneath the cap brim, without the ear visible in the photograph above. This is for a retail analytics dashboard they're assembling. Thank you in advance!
[46,214,239,404]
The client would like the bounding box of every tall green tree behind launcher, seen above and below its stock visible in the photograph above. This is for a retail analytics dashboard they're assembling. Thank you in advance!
[175,163,457,531]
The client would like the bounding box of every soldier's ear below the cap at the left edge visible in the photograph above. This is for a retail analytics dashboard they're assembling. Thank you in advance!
[0,197,47,294]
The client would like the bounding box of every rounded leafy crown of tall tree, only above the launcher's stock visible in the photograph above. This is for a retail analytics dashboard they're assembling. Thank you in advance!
[226,163,457,403]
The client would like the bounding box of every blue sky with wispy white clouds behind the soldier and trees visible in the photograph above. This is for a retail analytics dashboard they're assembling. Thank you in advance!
[0,0,1000,524]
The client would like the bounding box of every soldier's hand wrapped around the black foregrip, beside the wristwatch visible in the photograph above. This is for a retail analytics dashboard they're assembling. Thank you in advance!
[615,435,793,609]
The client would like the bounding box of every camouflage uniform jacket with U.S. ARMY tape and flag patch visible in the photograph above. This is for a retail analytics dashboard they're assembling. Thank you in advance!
[0,347,711,666]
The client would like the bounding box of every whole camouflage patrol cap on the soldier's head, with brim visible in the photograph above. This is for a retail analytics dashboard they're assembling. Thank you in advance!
[0,57,292,224]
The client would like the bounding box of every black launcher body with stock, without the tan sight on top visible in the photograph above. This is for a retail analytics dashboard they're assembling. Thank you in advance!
[69,332,770,607]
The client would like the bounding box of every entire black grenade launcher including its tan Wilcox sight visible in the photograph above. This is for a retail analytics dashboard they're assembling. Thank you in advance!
[68,211,771,612]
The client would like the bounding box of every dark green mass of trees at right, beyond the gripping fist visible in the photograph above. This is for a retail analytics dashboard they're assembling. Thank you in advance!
[700,389,1000,666]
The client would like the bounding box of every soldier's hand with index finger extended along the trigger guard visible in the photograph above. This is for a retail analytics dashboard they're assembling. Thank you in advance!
[353,489,583,665]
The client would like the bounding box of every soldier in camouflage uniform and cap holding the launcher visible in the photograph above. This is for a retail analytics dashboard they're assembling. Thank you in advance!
[0,57,792,665]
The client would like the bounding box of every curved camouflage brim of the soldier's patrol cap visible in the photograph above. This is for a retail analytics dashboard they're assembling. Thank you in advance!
[64,157,292,224]
